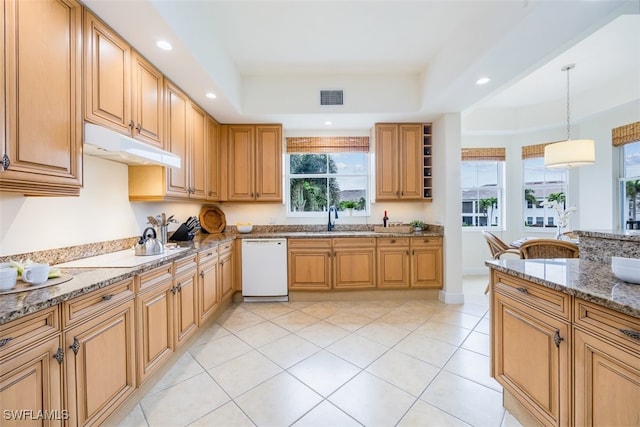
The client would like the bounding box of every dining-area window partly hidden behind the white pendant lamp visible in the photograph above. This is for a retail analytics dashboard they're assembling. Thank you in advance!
[522,144,568,229]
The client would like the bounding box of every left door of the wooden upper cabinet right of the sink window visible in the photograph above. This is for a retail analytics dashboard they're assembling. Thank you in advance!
[375,124,400,200]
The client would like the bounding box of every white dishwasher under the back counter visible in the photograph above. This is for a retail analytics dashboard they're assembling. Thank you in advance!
[242,239,289,302]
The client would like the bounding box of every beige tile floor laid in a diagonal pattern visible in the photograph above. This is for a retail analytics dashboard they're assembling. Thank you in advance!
[120,276,519,427]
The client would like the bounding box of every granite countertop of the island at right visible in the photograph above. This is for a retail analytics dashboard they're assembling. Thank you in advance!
[485,258,640,318]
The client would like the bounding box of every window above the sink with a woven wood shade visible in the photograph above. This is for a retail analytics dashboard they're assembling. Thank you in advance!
[286,137,370,216]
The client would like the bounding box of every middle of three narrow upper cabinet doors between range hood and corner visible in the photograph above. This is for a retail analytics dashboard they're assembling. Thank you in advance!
[188,103,209,200]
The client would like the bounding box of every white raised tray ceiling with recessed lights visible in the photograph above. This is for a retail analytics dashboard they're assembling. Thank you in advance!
[84,0,640,131]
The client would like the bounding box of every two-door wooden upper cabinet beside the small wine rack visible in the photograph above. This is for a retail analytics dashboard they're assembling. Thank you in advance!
[375,123,423,200]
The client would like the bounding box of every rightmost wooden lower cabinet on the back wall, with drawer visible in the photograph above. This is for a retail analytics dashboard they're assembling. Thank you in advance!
[411,237,444,289]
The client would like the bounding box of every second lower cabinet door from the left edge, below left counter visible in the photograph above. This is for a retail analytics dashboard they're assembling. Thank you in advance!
[64,300,136,425]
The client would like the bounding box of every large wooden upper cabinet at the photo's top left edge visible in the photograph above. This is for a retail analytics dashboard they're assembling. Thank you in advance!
[0,0,82,196]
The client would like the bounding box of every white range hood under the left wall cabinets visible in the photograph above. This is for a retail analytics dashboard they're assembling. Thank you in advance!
[84,122,180,168]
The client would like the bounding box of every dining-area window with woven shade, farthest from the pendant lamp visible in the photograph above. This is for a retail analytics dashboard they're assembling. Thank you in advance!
[461,148,505,227]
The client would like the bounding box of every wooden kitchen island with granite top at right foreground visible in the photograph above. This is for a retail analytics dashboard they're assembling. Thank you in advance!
[486,258,640,426]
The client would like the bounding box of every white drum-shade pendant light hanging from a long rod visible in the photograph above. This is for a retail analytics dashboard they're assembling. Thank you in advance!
[544,64,596,168]
